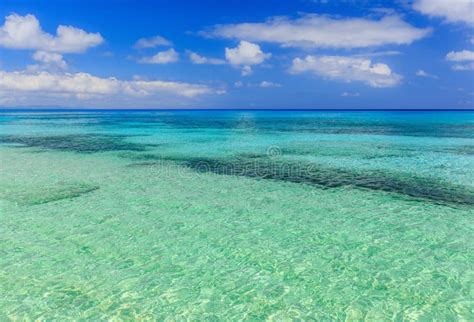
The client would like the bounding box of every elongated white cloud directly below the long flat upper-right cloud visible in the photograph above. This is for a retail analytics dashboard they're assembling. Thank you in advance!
[290,55,402,87]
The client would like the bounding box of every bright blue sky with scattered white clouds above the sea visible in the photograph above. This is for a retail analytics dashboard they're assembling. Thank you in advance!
[0,0,474,109]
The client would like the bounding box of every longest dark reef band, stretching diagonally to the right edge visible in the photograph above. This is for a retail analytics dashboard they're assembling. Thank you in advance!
[129,155,474,206]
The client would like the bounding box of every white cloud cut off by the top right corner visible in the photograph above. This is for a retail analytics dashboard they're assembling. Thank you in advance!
[413,0,474,25]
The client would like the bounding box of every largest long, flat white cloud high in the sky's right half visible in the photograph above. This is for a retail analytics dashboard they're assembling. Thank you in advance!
[204,14,431,48]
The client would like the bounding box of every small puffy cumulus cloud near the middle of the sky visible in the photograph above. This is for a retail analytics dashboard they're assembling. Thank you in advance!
[225,40,271,76]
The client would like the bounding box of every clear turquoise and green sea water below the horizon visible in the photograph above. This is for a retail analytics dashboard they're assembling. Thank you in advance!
[0,111,474,321]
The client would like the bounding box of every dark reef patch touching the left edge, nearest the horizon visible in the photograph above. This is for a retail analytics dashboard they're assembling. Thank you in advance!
[0,134,147,153]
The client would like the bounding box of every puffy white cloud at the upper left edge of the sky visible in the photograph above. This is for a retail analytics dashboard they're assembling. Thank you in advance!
[0,14,104,53]
